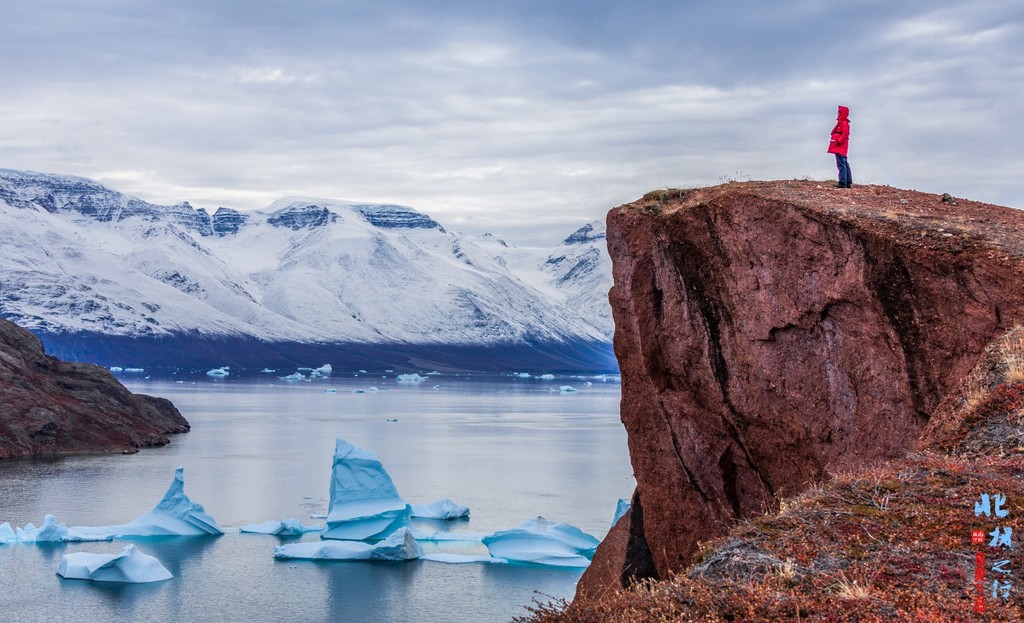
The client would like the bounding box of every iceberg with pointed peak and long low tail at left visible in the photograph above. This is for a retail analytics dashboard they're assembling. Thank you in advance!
[71,467,224,538]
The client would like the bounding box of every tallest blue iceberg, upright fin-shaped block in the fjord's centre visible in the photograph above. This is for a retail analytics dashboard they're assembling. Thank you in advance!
[321,440,410,541]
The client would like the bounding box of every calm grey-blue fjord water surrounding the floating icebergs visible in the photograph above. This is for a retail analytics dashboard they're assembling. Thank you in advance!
[0,375,634,622]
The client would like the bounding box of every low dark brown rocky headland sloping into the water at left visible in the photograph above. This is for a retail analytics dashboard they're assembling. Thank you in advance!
[0,319,188,459]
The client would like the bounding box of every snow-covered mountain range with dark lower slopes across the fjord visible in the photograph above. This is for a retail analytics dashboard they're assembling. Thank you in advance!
[0,169,614,369]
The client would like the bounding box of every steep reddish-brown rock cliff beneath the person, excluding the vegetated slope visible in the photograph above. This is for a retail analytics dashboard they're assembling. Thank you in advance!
[578,181,1024,594]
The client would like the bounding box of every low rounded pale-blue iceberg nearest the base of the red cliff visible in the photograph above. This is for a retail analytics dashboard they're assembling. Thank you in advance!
[483,517,599,567]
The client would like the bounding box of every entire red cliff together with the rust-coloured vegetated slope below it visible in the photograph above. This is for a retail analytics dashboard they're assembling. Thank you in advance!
[536,181,1024,621]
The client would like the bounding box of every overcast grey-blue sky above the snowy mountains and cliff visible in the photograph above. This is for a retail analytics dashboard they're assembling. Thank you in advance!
[0,0,1024,244]
